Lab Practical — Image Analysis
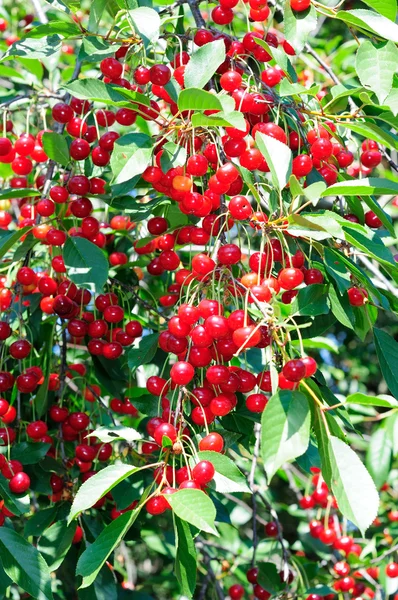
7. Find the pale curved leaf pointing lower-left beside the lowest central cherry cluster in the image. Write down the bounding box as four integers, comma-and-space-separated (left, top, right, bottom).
68, 463, 139, 523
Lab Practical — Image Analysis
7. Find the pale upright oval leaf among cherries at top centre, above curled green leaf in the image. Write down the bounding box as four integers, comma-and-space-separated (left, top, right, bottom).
184, 40, 225, 89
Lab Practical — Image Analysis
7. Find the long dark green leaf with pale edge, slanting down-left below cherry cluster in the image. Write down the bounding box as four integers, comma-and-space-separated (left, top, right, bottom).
76, 507, 140, 588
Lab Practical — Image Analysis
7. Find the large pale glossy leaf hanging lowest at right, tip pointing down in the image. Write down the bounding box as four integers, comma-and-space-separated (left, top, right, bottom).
329, 435, 379, 533
